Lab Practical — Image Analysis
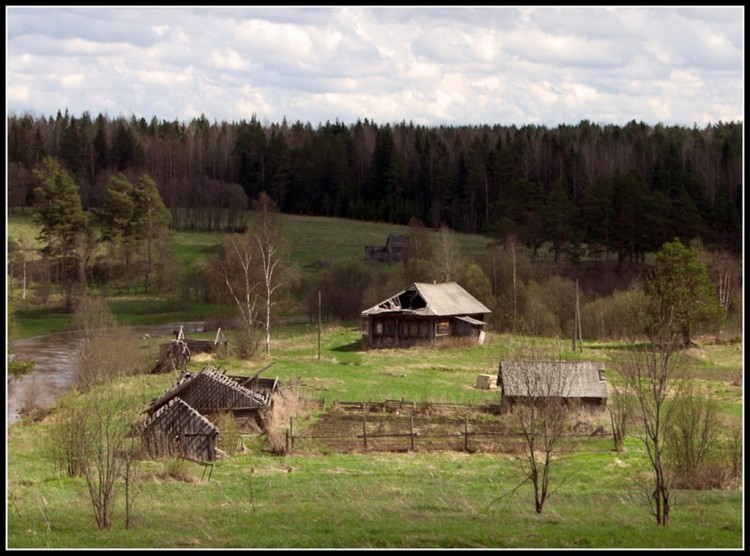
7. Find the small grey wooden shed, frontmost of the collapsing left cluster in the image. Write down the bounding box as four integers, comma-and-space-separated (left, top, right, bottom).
138, 398, 219, 461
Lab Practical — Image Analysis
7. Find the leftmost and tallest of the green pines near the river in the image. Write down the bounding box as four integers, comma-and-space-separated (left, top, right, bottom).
34, 157, 87, 308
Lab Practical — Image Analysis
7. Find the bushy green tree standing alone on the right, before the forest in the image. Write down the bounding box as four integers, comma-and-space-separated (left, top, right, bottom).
645, 239, 724, 347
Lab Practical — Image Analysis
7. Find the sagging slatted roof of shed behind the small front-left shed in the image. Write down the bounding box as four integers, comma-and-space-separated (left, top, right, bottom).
146, 366, 268, 413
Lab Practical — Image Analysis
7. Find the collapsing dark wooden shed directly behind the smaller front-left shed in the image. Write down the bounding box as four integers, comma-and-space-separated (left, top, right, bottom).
146, 366, 270, 426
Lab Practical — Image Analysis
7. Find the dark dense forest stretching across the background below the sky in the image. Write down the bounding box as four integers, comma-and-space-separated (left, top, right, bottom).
8, 110, 743, 261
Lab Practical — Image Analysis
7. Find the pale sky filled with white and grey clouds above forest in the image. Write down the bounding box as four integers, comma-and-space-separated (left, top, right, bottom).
6, 6, 744, 127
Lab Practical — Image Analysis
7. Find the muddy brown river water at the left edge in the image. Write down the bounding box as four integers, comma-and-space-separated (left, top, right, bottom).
6, 322, 205, 425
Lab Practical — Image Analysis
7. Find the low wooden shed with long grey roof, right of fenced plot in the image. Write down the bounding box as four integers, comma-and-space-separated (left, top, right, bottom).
497, 361, 609, 412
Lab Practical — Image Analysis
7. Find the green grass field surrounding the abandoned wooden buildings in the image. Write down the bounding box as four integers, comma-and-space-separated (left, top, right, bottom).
6, 212, 744, 549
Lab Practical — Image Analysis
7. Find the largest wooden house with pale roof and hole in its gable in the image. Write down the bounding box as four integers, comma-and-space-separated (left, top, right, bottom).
361, 282, 491, 347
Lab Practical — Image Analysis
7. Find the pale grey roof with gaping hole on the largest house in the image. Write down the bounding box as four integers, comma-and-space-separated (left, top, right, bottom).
362, 282, 492, 317
